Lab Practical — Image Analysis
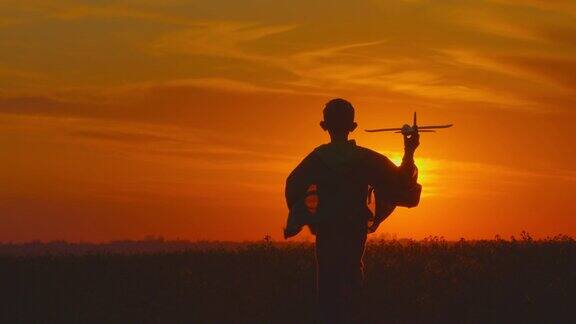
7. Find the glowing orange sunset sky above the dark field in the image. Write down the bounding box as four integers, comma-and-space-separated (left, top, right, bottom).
0, 0, 576, 241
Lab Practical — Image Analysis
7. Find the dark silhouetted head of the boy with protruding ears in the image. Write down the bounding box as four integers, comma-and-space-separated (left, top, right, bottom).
320, 98, 358, 136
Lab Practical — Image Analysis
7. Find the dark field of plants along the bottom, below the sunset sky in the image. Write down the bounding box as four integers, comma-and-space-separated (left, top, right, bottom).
0, 234, 576, 323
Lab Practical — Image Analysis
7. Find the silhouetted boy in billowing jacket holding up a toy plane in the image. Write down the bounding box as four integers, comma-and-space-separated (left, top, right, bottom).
284, 99, 421, 323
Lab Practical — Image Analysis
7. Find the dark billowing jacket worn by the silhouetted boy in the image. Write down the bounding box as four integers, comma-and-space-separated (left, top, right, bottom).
284, 140, 422, 238
